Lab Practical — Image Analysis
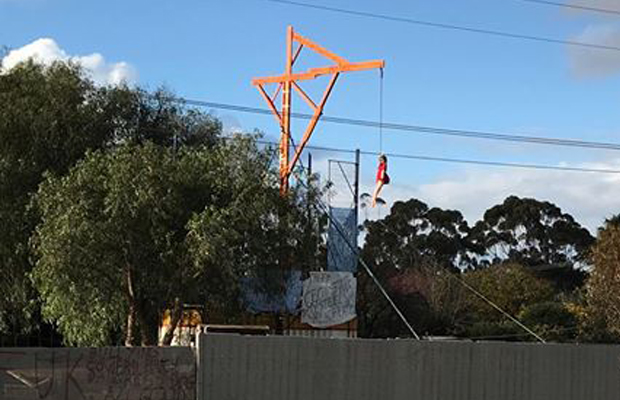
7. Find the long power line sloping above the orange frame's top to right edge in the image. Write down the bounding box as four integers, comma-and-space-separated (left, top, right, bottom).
266, 0, 620, 51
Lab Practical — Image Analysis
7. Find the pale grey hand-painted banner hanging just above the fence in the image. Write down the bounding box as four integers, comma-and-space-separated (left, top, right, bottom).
301, 272, 357, 328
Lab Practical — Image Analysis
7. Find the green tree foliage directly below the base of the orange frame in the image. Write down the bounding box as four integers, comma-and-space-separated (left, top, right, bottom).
188, 159, 326, 322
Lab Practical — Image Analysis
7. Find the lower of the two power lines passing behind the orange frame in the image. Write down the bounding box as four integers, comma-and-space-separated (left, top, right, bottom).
258, 140, 620, 174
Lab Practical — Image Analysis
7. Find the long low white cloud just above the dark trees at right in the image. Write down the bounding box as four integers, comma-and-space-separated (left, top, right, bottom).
376, 159, 620, 233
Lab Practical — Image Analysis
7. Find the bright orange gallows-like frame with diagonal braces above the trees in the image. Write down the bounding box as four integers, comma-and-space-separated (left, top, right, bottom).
252, 26, 385, 195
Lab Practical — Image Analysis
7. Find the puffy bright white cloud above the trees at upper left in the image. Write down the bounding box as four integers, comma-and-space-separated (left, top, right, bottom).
2, 38, 138, 85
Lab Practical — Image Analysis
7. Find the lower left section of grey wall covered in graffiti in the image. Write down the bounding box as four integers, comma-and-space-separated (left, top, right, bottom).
0, 347, 196, 400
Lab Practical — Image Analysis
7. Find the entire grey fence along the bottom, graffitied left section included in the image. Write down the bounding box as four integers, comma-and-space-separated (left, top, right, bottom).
0, 334, 620, 400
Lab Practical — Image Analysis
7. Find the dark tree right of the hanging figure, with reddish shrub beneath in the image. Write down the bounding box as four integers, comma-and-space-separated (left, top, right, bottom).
358, 199, 474, 337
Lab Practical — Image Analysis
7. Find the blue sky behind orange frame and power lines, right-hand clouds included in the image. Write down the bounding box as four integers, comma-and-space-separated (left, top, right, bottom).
0, 0, 620, 229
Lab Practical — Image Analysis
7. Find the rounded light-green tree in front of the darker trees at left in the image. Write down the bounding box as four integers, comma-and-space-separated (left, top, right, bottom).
33, 145, 195, 345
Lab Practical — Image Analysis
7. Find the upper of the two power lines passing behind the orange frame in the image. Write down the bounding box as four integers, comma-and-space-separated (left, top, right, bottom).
183, 98, 620, 151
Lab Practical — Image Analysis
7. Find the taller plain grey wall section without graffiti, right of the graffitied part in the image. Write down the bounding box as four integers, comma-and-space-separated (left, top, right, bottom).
198, 335, 620, 400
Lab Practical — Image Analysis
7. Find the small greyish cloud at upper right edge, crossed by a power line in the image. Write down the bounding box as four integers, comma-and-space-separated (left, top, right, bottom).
568, 24, 620, 77
